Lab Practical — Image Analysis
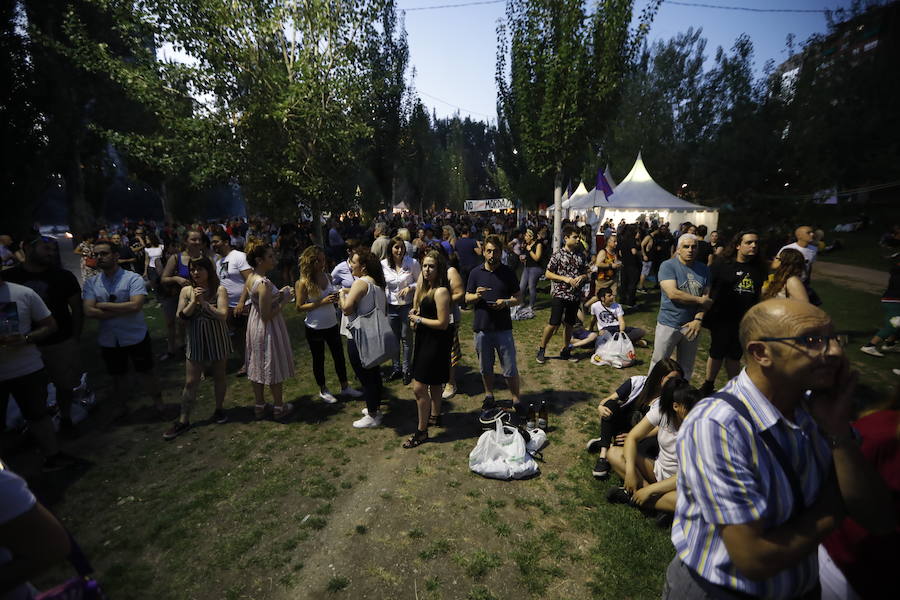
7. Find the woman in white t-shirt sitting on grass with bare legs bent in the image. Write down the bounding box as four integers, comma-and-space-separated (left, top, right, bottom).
606, 378, 701, 514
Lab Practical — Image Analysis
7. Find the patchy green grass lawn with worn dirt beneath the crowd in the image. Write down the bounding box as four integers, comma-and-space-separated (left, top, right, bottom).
12, 283, 900, 600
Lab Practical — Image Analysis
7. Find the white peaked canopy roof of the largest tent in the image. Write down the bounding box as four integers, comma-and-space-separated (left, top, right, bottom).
598, 152, 719, 231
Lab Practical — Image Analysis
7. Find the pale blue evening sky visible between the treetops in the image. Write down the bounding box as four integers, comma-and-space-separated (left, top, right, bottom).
397, 0, 850, 121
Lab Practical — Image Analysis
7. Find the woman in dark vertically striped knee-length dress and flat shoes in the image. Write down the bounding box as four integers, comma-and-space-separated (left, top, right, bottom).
163, 256, 231, 440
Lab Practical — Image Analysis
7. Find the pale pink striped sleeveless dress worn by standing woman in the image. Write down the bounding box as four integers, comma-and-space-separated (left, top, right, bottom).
246, 277, 294, 385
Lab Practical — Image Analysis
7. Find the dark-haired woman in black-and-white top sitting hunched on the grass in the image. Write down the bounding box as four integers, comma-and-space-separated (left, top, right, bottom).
587, 358, 684, 478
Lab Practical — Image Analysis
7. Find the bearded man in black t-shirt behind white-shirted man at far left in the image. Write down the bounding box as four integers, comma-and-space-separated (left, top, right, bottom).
3, 234, 84, 436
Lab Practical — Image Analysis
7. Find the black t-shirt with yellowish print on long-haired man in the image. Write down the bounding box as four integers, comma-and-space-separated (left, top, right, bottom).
703, 261, 766, 326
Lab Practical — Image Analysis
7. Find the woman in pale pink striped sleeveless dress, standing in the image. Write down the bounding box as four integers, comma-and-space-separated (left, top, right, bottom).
242, 244, 294, 419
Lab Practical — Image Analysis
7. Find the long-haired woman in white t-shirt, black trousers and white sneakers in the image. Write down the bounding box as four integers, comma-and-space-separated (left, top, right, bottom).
294, 246, 362, 404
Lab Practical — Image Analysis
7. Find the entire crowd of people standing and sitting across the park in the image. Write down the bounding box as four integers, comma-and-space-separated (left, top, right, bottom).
0, 211, 900, 598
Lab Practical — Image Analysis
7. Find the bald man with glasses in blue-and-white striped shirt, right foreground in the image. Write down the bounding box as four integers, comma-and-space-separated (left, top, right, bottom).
663, 299, 895, 599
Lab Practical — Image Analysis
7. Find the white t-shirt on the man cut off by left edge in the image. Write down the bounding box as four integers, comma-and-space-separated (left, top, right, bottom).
0, 282, 50, 381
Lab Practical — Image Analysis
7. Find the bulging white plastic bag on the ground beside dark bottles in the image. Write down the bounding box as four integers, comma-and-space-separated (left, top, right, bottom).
469, 419, 540, 479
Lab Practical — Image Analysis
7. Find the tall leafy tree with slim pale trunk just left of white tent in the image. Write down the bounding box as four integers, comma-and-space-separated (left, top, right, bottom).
496, 0, 659, 247
